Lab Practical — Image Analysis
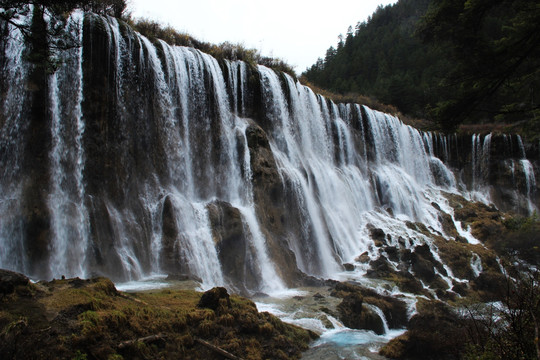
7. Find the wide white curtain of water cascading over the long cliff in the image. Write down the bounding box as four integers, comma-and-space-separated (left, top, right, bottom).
0, 10, 537, 292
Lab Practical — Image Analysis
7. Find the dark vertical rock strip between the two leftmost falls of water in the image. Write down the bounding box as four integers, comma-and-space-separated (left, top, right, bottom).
18, 7, 52, 276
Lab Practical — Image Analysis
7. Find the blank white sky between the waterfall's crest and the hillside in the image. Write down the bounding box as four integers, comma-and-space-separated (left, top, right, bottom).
128, 0, 396, 74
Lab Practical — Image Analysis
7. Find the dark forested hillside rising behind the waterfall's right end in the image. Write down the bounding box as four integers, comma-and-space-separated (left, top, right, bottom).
304, 0, 540, 137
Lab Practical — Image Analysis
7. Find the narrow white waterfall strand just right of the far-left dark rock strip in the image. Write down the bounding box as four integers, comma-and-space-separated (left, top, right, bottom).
48, 12, 89, 277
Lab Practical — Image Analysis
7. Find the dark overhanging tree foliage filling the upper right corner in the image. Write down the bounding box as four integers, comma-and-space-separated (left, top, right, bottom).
418, 0, 540, 130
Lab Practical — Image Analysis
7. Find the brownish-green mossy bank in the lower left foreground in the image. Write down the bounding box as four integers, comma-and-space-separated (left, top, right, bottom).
0, 278, 315, 360
